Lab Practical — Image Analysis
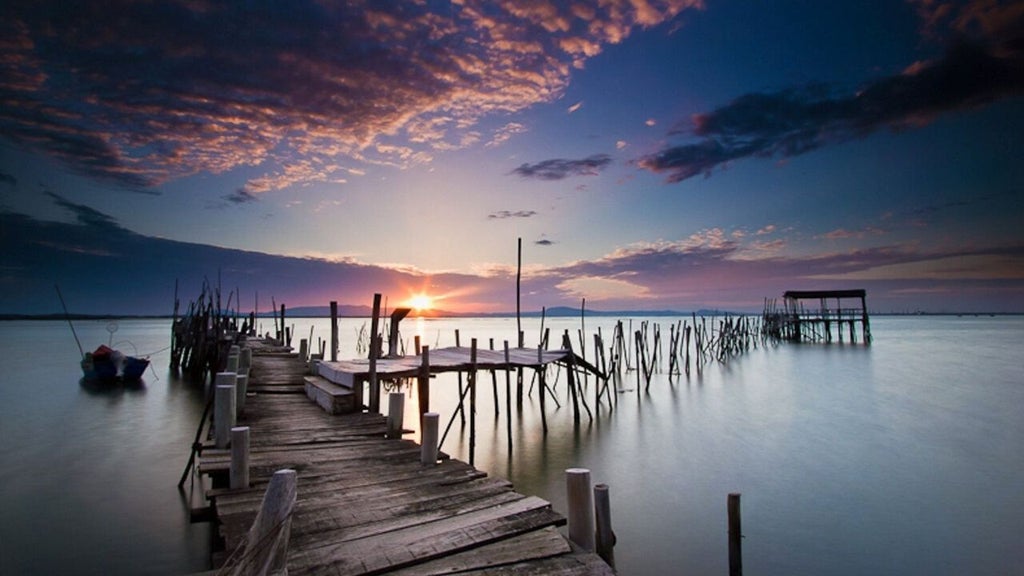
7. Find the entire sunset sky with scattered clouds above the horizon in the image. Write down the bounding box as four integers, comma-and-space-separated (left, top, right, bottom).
0, 0, 1024, 314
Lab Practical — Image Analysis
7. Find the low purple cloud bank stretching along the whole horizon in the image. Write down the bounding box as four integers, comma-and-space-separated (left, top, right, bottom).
0, 202, 1024, 314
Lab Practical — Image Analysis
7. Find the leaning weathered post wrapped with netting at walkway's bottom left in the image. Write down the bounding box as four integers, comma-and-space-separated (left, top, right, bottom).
230, 469, 298, 576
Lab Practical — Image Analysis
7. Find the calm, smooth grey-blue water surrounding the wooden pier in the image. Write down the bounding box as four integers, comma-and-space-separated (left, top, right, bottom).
0, 317, 1024, 575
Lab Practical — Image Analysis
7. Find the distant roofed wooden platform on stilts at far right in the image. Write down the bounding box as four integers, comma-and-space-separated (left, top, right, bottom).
763, 290, 871, 344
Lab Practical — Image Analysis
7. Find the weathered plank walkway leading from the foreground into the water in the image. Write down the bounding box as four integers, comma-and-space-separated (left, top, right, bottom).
199, 352, 613, 576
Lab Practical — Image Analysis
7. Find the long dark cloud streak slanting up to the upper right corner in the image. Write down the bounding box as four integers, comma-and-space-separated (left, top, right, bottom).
637, 3, 1024, 182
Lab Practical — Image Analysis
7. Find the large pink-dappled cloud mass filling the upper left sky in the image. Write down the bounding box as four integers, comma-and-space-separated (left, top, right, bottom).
0, 0, 701, 194
